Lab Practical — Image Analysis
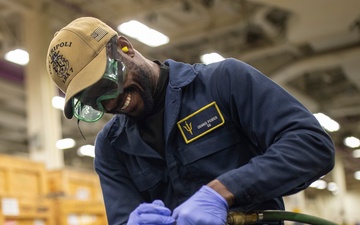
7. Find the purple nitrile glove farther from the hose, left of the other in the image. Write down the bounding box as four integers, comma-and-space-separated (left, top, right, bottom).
127, 200, 175, 225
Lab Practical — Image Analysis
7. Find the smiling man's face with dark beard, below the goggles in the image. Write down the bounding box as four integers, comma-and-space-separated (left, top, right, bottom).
102, 55, 156, 119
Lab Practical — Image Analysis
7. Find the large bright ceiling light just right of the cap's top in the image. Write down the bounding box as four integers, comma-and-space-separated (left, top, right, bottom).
117, 20, 169, 47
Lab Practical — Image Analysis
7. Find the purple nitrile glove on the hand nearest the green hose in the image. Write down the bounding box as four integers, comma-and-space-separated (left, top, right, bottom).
172, 186, 229, 225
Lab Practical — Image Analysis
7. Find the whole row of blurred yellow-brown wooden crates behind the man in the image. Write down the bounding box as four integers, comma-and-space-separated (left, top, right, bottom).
0, 154, 107, 225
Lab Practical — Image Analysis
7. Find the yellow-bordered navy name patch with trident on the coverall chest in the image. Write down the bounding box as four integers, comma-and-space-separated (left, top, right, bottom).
177, 102, 224, 144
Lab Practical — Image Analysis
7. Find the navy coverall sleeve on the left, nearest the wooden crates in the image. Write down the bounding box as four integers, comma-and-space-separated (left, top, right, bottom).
94, 127, 142, 225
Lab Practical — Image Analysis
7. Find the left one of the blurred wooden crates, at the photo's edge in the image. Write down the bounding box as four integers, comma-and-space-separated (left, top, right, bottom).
0, 155, 55, 225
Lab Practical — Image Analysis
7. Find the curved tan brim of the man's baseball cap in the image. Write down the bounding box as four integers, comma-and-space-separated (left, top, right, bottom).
64, 46, 107, 119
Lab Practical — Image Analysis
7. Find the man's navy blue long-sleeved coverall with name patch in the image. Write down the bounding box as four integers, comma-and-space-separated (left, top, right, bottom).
94, 59, 335, 225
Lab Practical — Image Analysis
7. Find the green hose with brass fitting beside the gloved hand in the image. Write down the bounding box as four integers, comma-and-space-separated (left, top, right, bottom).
227, 210, 338, 225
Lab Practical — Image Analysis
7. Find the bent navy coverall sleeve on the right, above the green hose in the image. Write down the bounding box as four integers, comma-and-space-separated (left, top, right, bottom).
211, 59, 335, 211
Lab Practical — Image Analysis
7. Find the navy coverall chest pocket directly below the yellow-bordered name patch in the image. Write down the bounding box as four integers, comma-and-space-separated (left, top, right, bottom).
179, 126, 242, 182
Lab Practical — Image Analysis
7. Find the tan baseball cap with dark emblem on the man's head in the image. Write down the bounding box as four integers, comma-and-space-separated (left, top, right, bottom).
46, 17, 117, 119
